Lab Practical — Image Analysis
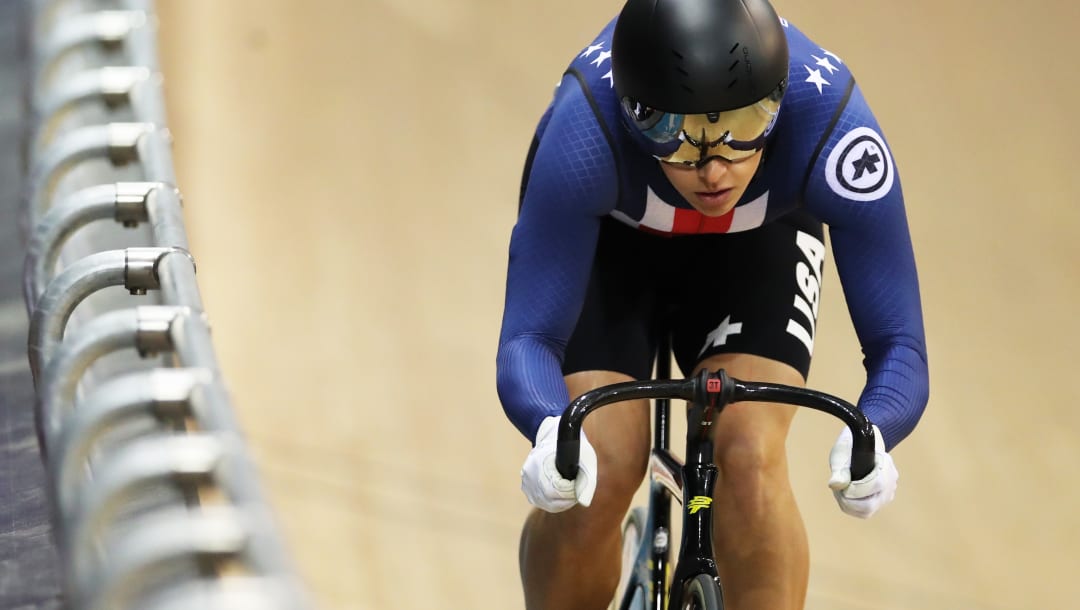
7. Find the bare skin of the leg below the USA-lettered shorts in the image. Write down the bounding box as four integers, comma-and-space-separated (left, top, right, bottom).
702, 354, 809, 610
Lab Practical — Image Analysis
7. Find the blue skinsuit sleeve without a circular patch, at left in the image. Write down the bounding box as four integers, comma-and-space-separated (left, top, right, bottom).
496, 74, 619, 440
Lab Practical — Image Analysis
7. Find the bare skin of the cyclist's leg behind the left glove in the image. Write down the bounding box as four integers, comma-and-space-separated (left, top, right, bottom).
518, 371, 650, 610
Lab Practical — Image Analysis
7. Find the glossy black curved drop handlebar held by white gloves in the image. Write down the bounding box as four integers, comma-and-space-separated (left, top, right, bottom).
555, 369, 875, 480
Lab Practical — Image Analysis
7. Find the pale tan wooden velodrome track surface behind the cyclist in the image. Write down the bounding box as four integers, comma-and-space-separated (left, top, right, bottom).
159, 0, 1080, 610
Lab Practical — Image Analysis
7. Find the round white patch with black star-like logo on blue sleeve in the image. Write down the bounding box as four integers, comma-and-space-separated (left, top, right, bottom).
825, 127, 895, 201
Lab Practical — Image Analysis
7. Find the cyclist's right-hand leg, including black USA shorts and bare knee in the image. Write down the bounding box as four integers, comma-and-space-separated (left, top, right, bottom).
672, 211, 825, 610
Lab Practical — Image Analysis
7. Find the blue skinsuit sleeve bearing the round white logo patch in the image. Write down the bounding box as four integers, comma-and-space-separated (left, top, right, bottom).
805, 81, 930, 449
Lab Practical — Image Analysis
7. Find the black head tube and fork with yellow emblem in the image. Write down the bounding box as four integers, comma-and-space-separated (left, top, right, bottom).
667, 443, 718, 610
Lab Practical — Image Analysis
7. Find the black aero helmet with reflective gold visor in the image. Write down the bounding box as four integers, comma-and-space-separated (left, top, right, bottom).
611, 0, 788, 164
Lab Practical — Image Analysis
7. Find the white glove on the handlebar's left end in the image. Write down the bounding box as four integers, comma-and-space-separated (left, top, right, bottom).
522, 417, 596, 513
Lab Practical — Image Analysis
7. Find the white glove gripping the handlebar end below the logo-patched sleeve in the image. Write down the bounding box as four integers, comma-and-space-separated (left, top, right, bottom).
828, 425, 900, 519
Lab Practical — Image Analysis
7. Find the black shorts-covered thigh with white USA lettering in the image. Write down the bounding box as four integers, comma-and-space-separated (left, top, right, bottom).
671, 213, 825, 380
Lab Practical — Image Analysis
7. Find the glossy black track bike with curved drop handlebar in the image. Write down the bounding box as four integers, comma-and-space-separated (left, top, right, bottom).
555, 343, 875, 610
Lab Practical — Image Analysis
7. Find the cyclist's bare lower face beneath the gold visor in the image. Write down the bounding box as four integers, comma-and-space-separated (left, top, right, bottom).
660, 150, 761, 216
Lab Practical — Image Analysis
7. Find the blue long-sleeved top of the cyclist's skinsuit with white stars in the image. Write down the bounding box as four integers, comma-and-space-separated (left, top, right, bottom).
497, 21, 929, 448
